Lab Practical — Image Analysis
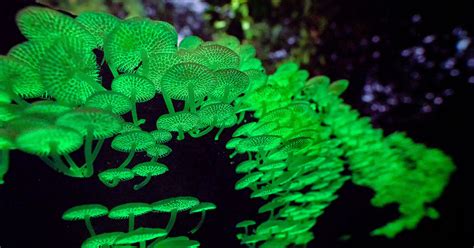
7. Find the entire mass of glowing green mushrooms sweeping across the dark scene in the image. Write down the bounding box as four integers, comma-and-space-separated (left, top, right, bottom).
0, 4, 454, 248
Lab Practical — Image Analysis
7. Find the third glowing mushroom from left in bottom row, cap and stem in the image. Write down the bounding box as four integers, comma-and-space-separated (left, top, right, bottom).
152, 196, 199, 233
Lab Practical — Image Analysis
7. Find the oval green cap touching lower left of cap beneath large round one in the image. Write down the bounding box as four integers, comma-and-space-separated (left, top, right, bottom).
85, 91, 132, 115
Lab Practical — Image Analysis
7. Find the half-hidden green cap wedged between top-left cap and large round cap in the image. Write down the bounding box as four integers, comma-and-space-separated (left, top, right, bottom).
75, 11, 120, 48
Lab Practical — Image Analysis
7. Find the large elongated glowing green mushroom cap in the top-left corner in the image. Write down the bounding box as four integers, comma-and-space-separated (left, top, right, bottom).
16, 6, 95, 48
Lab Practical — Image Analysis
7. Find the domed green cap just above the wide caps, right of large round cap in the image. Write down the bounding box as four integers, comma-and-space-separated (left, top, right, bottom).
194, 44, 240, 71
